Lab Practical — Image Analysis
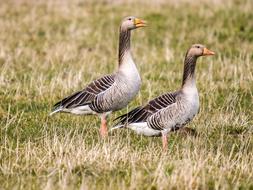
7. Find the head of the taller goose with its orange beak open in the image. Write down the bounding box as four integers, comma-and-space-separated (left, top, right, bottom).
120, 16, 147, 30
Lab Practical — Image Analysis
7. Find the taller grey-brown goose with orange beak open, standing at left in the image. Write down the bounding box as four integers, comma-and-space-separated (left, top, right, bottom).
49, 16, 146, 137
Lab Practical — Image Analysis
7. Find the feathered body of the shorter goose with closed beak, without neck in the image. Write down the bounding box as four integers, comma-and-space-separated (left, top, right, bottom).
113, 89, 199, 136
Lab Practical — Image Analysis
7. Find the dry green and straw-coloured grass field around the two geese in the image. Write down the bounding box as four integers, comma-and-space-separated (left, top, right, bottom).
0, 0, 253, 190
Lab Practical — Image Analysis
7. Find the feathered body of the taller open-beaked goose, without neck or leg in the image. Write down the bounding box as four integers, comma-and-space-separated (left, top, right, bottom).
51, 55, 141, 115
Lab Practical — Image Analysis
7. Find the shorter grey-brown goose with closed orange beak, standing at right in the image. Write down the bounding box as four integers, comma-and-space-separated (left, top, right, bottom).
111, 44, 215, 150
